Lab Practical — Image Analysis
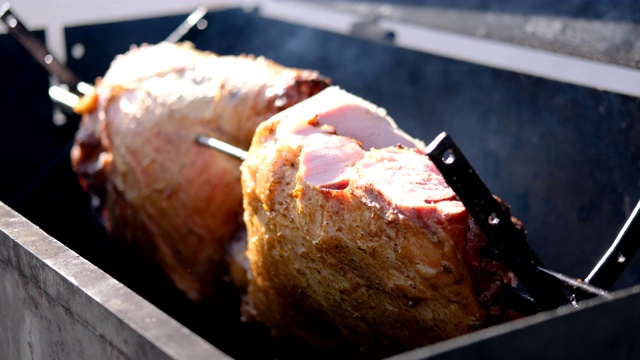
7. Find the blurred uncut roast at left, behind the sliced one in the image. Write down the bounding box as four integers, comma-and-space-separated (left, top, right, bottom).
71, 43, 328, 301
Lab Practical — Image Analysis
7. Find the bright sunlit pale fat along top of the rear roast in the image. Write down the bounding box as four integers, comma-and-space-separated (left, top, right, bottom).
99, 42, 284, 119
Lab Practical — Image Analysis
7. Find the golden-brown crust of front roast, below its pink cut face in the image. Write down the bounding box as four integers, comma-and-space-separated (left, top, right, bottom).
242, 121, 504, 356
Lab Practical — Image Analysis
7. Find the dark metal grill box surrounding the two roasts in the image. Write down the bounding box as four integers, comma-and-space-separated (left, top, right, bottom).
0, 3, 640, 359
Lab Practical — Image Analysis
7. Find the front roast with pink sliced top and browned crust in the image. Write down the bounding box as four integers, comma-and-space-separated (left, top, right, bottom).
241, 87, 515, 357
